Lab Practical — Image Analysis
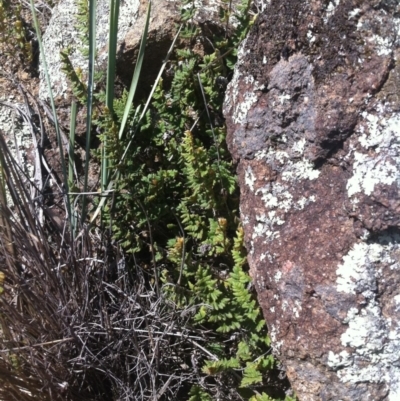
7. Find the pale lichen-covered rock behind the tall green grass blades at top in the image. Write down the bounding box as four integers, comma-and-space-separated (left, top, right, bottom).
40, 0, 239, 101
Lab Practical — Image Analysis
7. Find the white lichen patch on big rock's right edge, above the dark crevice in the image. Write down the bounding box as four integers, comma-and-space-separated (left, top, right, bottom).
347, 105, 400, 197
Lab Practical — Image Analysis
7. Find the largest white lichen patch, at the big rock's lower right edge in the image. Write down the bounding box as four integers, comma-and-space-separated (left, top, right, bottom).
328, 235, 400, 401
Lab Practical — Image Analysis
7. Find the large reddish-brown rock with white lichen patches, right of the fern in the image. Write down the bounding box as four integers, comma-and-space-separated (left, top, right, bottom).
225, 0, 400, 401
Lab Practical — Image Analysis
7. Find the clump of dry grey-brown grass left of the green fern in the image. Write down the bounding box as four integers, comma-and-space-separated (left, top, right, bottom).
0, 131, 209, 400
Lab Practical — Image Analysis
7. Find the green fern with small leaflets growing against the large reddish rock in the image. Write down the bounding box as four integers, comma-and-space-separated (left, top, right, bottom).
66, 1, 294, 401
